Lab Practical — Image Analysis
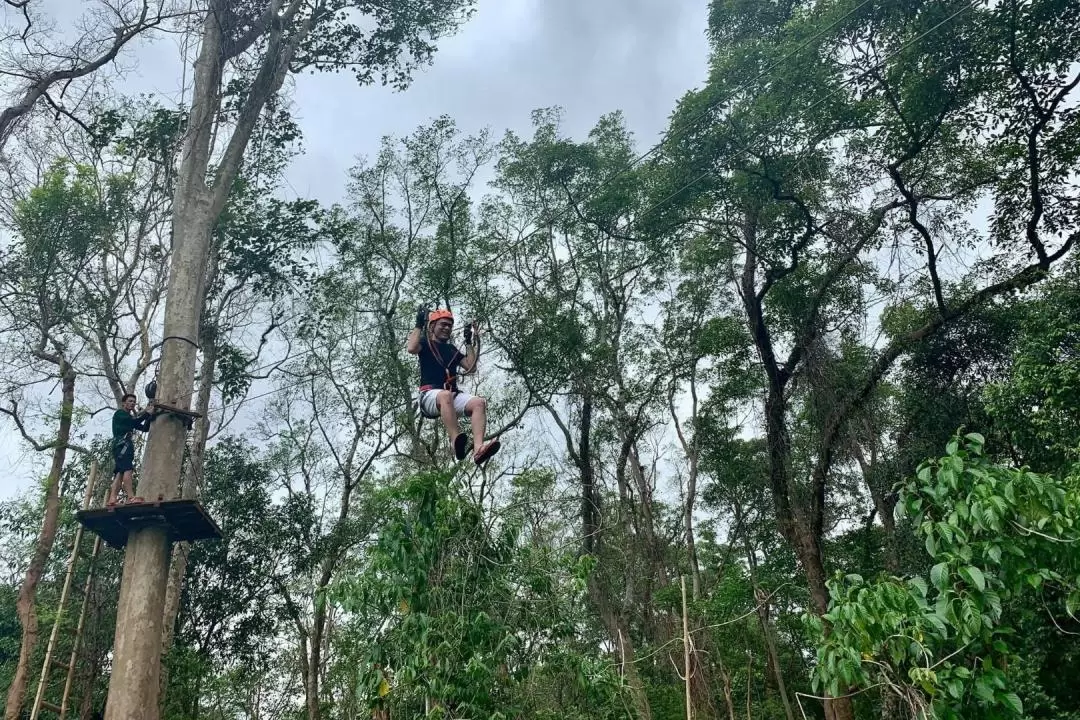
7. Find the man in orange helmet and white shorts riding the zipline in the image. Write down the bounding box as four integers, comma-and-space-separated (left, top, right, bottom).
405, 308, 500, 465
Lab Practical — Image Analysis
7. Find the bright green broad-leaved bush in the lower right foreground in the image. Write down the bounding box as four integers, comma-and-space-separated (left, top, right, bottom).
813, 433, 1080, 718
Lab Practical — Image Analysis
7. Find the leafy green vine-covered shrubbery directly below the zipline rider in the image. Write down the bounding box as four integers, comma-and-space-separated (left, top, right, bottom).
332, 473, 618, 720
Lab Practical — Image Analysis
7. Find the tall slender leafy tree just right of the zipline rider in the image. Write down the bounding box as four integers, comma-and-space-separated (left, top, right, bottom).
472, 109, 674, 718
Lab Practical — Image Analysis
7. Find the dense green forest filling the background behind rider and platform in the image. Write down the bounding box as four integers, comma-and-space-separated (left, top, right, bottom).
0, 0, 1080, 720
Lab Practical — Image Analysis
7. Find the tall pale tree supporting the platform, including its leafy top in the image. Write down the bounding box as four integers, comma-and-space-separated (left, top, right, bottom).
106, 0, 471, 720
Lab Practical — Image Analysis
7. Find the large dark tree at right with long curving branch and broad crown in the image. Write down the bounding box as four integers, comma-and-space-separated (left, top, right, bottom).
669, 2, 1080, 720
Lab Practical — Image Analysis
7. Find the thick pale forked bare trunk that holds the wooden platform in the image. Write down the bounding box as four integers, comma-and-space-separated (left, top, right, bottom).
106, 0, 310, 720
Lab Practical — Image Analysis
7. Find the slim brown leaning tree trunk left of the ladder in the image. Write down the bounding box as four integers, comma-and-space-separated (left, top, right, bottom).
4, 367, 75, 720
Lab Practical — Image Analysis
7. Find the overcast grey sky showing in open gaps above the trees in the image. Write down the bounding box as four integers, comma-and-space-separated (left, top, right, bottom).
0, 0, 707, 498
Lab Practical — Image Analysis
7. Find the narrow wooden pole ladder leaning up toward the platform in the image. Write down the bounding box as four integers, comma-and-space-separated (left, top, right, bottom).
30, 460, 102, 720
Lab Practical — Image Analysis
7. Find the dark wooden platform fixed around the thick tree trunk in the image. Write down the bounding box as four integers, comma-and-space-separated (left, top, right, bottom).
76, 500, 221, 547
